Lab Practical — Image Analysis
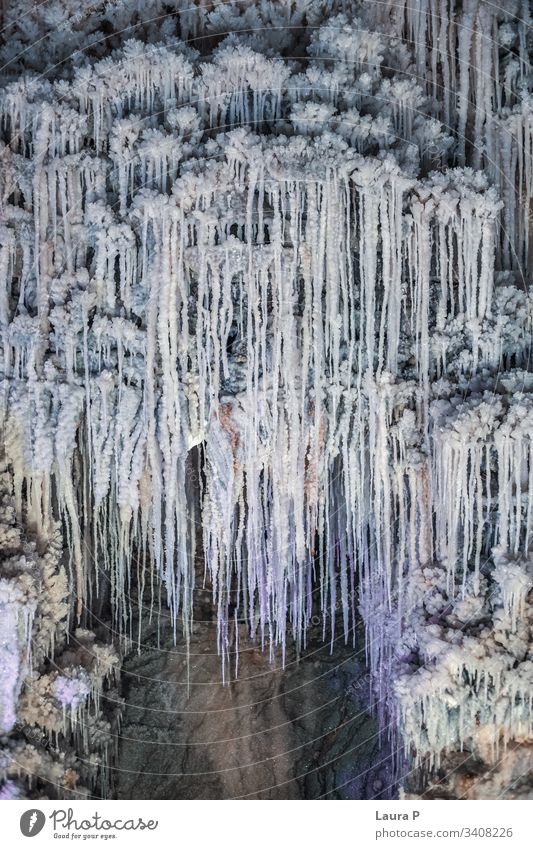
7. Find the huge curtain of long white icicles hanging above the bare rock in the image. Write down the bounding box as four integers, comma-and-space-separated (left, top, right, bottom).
0, 0, 533, 796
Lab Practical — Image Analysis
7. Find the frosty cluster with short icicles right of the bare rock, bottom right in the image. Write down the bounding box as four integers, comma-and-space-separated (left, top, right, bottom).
393, 549, 533, 798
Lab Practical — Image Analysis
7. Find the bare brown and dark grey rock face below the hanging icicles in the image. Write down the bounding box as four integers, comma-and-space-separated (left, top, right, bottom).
115, 607, 395, 799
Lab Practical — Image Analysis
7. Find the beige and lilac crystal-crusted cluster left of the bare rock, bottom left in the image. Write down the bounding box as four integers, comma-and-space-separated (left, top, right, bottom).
0, 469, 120, 798
